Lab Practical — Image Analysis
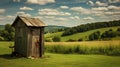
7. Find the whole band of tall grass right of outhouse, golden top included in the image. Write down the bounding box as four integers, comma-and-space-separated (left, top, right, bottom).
45, 41, 120, 56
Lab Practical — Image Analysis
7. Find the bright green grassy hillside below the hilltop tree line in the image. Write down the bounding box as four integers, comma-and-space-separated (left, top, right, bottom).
45, 26, 120, 41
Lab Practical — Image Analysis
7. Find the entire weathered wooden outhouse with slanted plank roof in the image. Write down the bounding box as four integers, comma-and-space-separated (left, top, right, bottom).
12, 16, 45, 58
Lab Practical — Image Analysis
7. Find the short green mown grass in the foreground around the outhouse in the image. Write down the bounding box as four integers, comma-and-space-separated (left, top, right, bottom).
0, 42, 120, 67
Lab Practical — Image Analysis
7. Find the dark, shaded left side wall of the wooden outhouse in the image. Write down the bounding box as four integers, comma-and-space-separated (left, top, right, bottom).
15, 20, 28, 56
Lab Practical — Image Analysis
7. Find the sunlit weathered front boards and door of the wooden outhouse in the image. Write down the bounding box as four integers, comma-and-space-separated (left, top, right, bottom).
28, 27, 40, 57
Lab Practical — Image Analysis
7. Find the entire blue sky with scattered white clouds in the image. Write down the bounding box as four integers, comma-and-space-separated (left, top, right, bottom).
0, 0, 120, 27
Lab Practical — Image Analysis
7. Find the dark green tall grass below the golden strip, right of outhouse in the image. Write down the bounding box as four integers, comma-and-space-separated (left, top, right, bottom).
45, 45, 120, 56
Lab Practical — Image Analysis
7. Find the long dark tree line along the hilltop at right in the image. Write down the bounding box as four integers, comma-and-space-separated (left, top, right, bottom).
62, 20, 120, 36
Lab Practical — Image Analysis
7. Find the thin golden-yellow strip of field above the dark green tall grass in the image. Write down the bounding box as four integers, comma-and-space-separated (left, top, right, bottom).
45, 40, 120, 47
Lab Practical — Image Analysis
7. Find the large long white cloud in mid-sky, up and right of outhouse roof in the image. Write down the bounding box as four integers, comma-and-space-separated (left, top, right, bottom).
38, 8, 71, 16
